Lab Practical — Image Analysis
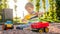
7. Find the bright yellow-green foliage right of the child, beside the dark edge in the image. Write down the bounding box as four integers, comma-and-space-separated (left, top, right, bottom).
40, 0, 60, 22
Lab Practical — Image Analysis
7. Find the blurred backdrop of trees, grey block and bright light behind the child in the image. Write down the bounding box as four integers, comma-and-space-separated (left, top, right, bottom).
0, 0, 60, 23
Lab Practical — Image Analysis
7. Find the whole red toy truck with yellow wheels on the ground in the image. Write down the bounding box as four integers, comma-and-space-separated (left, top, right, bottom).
31, 22, 49, 33
